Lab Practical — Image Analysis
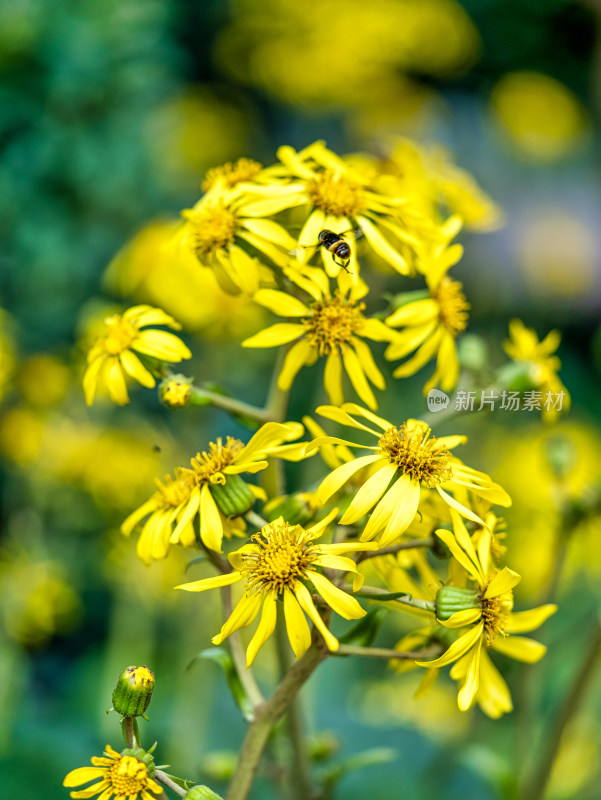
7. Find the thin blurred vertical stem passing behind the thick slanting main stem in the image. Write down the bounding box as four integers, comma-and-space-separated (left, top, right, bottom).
275, 617, 312, 800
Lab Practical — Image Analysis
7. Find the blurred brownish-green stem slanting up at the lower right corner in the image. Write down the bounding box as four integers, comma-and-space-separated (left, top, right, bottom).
523, 622, 601, 800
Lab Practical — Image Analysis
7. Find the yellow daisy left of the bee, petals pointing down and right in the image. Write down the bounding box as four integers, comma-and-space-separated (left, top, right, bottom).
176, 181, 295, 294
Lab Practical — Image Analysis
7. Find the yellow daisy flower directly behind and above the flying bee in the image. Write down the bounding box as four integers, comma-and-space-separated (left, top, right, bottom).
238, 141, 439, 277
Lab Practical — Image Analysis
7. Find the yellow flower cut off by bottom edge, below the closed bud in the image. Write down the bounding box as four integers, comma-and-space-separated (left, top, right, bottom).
63, 744, 163, 800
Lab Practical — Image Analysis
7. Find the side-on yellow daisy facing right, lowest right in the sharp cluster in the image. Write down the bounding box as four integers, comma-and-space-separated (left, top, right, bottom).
417, 517, 557, 717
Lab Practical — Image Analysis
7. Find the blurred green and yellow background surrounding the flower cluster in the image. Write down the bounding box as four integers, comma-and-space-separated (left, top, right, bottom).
0, 0, 601, 800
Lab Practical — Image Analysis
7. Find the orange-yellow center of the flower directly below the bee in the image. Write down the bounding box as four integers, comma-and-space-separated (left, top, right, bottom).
302, 292, 365, 356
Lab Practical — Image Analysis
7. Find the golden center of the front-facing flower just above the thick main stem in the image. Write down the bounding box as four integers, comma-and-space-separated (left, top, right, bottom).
241, 521, 311, 594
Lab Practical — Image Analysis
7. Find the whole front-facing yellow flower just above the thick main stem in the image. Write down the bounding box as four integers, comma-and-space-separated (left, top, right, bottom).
176, 508, 374, 666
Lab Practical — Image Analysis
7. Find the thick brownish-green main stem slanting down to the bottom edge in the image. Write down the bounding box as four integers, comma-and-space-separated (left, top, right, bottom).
226, 634, 328, 800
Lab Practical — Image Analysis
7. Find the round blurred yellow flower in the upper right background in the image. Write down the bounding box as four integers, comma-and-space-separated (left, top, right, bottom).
491, 72, 588, 161
